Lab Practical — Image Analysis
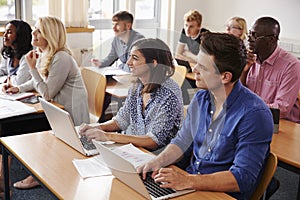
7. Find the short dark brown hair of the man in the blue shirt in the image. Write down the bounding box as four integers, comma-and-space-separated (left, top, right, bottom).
200, 32, 247, 82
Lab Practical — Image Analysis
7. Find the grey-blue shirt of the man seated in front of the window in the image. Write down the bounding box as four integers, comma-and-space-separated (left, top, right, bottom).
101, 30, 144, 72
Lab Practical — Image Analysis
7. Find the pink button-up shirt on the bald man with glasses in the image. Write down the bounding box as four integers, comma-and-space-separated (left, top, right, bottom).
246, 47, 300, 123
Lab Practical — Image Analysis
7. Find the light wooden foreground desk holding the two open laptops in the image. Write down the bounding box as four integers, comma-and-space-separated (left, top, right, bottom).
0, 131, 233, 200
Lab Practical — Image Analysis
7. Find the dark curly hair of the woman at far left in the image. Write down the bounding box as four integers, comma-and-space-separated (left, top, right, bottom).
1, 20, 33, 60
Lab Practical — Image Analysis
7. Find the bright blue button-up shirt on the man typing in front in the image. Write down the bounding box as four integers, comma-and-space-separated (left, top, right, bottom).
171, 81, 273, 199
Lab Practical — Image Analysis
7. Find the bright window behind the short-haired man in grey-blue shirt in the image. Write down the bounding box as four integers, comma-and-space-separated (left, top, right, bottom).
88, 0, 161, 61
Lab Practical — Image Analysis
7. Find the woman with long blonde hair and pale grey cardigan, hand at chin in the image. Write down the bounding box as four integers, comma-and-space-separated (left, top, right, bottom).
2, 17, 89, 189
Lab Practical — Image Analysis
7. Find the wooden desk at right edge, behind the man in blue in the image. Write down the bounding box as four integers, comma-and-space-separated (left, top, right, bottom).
271, 120, 300, 200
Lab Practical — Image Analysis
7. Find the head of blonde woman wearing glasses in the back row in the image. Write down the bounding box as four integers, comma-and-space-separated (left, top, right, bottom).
226, 17, 248, 41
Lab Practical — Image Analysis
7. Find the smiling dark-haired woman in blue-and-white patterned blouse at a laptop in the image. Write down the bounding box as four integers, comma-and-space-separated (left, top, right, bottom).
80, 39, 183, 150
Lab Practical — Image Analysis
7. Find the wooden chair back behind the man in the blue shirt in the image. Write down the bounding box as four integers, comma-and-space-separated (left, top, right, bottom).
251, 152, 277, 200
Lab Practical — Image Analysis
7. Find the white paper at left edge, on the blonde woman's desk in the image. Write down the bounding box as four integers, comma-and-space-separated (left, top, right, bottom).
0, 99, 36, 119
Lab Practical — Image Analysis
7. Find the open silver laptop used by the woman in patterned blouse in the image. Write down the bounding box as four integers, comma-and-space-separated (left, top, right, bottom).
39, 98, 98, 156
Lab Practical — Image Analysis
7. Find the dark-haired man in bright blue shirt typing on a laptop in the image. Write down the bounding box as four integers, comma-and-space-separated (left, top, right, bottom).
138, 33, 273, 199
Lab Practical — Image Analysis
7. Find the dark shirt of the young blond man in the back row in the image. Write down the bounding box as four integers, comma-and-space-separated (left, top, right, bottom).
179, 28, 208, 55
